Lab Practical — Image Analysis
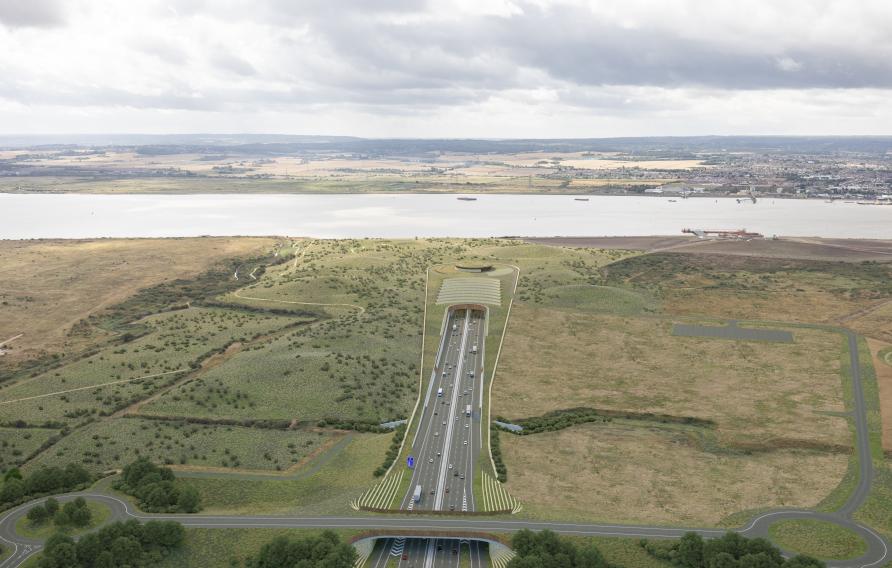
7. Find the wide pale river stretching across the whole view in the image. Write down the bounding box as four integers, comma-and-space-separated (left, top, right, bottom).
0, 194, 892, 239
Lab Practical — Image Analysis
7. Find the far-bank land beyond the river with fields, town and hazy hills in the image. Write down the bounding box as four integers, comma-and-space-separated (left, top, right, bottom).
0, 135, 892, 204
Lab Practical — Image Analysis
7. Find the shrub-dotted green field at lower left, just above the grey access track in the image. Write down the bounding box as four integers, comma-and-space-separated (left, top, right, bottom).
26, 417, 333, 473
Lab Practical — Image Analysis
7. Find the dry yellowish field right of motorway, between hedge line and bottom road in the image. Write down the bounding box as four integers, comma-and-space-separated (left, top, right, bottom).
500, 424, 847, 526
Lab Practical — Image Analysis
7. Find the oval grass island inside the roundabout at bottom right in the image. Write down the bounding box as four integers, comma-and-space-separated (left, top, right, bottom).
768, 519, 867, 560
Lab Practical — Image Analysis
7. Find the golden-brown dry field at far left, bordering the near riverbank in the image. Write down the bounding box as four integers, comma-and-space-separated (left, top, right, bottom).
0, 237, 277, 366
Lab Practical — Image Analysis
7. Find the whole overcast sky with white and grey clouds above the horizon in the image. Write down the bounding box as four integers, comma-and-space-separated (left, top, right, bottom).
0, 0, 892, 138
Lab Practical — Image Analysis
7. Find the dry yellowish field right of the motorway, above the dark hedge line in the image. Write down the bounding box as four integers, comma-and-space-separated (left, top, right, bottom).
493, 304, 851, 448
